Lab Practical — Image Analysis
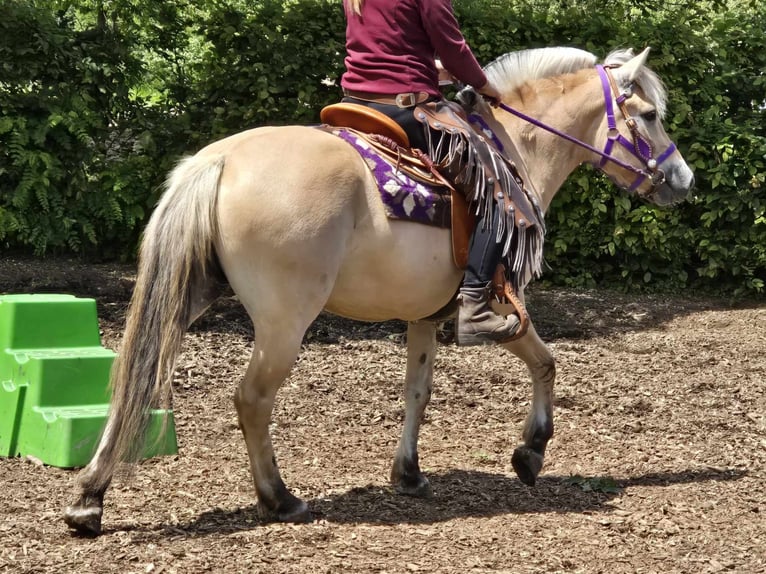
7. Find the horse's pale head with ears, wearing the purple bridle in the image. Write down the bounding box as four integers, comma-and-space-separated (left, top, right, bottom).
595, 48, 694, 205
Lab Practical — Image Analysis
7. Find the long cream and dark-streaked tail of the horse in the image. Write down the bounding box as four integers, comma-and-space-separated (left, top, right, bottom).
80, 155, 224, 492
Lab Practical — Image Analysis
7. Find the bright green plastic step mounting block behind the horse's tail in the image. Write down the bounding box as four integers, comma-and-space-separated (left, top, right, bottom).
0, 295, 177, 468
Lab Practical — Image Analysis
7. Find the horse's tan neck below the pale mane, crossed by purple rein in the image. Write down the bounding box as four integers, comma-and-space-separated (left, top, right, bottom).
491, 74, 602, 212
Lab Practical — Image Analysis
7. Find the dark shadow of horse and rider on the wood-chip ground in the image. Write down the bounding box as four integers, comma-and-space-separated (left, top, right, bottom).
122, 468, 747, 537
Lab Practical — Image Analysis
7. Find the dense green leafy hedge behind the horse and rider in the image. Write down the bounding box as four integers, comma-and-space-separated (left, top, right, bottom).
0, 0, 766, 295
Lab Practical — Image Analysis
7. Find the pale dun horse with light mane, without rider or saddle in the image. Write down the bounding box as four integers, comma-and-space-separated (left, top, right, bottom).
64, 47, 694, 535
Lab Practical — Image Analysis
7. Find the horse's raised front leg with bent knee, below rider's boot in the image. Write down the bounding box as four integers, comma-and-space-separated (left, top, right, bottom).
505, 325, 556, 486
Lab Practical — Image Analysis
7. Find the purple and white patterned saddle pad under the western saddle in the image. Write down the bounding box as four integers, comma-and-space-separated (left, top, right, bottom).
332, 129, 452, 229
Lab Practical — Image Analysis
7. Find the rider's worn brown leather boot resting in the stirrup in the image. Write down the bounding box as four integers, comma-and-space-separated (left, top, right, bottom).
455, 283, 519, 346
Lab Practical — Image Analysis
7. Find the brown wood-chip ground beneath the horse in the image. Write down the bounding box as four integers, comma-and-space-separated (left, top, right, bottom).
0, 259, 766, 574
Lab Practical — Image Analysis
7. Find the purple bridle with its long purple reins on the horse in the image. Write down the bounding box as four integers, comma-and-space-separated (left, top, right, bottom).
470, 65, 676, 198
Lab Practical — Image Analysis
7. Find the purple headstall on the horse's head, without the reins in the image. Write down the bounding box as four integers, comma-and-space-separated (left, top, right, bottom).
596, 65, 676, 197
